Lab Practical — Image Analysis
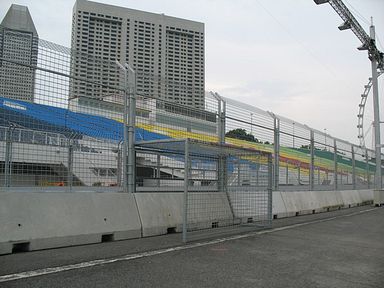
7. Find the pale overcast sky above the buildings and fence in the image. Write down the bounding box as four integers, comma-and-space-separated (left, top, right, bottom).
0, 0, 384, 146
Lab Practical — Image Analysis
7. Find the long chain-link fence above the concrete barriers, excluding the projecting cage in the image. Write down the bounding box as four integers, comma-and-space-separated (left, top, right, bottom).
0, 29, 376, 192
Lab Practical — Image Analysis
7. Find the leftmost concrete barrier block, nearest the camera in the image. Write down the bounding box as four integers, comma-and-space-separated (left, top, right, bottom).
0, 192, 141, 254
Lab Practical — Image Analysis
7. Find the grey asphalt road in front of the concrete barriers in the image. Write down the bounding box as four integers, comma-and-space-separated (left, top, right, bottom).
0, 206, 384, 288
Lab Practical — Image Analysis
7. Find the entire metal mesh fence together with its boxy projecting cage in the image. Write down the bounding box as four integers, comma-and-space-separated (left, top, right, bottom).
0, 29, 375, 241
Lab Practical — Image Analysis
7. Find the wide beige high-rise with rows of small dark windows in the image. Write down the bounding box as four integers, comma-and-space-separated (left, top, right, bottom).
70, 0, 204, 108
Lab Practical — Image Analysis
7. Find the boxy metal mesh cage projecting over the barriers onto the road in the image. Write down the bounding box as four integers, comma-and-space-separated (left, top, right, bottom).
137, 138, 272, 242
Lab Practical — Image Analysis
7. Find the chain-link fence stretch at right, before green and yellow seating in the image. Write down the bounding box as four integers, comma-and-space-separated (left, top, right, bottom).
222, 97, 376, 191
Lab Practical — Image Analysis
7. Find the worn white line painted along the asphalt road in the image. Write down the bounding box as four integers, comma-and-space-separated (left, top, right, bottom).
0, 208, 378, 283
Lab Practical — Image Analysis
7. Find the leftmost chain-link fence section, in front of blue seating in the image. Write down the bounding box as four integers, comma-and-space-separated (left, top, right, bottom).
0, 31, 123, 191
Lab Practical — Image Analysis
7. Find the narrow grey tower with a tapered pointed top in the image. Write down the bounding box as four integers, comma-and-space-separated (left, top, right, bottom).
0, 4, 38, 102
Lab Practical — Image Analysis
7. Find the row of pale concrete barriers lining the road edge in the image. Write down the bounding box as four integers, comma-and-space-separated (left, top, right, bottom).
0, 190, 373, 254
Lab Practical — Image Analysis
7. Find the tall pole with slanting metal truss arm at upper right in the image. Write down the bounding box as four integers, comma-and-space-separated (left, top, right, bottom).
314, 0, 384, 190
